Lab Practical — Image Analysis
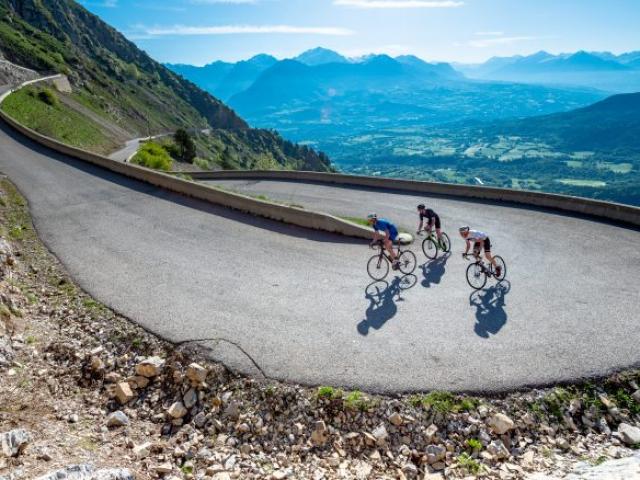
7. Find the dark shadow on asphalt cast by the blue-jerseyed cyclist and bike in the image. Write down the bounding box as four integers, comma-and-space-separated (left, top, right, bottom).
357, 274, 418, 336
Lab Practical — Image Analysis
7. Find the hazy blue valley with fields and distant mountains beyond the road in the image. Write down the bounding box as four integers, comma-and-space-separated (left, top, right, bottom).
169, 48, 640, 204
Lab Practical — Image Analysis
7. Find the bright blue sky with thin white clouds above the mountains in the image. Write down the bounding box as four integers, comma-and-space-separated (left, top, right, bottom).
80, 0, 640, 65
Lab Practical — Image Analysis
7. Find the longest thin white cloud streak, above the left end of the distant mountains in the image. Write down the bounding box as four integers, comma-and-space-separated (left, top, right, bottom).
138, 25, 354, 38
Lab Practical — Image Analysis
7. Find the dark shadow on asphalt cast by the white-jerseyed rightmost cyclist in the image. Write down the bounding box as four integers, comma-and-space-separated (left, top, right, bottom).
469, 280, 511, 338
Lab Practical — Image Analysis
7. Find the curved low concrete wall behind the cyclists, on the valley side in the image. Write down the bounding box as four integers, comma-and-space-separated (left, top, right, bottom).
184, 170, 640, 227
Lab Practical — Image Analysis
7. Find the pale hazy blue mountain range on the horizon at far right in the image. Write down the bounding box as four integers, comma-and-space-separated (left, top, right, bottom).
456, 51, 640, 93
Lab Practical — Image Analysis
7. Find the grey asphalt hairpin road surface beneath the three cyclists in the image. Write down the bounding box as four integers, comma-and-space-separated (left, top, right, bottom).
0, 95, 640, 392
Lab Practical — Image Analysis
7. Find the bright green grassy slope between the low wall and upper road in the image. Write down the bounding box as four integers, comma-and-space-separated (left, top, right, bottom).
2, 87, 118, 153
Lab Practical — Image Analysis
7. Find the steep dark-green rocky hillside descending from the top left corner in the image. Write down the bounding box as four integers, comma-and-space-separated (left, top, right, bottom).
0, 0, 328, 170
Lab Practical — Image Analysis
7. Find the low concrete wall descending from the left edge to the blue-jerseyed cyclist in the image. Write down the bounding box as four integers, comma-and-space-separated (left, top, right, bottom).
0, 80, 372, 239
